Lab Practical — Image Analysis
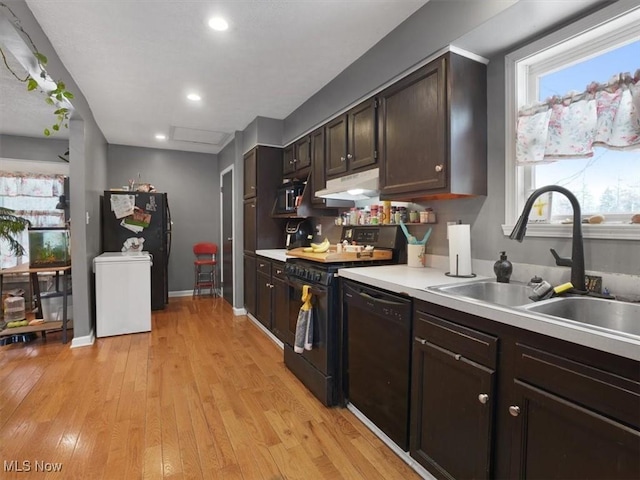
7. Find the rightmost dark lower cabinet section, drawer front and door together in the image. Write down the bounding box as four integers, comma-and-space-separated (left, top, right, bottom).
508, 343, 640, 480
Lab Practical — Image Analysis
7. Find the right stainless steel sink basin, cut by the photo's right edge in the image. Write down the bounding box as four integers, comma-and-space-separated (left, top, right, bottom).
522, 297, 640, 336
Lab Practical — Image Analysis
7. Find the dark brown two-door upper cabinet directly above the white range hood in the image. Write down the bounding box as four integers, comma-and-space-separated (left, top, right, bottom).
325, 98, 377, 178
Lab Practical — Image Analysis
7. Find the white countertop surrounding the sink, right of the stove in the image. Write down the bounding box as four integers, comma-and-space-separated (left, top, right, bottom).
338, 265, 640, 361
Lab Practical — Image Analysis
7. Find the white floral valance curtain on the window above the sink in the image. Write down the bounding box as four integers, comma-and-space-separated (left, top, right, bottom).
516, 70, 640, 165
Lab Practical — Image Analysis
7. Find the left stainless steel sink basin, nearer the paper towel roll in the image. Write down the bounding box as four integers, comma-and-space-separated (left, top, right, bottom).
429, 280, 533, 307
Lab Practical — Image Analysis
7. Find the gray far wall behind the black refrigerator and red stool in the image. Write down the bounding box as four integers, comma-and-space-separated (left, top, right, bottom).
107, 145, 220, 292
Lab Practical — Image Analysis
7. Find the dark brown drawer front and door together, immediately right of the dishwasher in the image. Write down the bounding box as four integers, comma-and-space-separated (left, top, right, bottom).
411, 311, 497, 479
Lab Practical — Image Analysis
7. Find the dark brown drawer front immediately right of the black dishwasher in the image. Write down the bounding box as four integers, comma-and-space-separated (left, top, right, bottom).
414, 312, 498, 369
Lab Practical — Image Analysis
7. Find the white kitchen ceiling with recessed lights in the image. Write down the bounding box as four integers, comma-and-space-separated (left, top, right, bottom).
16, 0, 426, 153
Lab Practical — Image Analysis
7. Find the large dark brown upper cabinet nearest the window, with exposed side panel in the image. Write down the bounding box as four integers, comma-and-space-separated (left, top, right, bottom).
378, 52, 487, 200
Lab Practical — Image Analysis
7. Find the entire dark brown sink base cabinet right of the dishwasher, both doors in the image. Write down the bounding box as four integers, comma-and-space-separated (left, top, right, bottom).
410, 300, 640, 480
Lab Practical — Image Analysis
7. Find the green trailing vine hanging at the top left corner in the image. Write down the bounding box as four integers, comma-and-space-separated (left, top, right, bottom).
0, 2, 73, 137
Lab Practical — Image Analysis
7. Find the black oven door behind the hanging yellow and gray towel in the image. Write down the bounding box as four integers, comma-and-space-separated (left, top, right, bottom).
286, 278, 332, 375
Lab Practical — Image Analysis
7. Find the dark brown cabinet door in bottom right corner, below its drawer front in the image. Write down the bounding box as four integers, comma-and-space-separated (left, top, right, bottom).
509, 380, 640, 480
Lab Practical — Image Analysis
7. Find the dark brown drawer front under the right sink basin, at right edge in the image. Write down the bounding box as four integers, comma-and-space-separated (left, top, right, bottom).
516, 343, 640, 428
